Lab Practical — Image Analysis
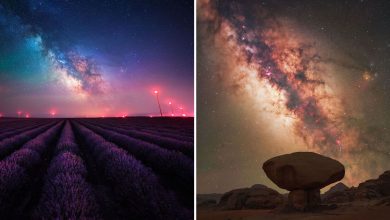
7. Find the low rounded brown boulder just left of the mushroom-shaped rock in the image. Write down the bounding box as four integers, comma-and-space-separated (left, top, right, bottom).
218, 184, 283, 210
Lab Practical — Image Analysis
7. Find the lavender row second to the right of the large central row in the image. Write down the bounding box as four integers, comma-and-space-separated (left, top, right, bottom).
78, 124, 194, 197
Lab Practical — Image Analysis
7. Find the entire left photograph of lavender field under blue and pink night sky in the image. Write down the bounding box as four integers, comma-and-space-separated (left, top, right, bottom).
0, 0, 194, 220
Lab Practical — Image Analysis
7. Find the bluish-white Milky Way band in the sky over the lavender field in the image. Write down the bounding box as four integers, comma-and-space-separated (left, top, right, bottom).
0, 1, 104, 95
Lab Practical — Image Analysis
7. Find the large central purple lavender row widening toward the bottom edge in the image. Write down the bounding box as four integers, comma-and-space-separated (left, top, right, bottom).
34, 122, 100, 219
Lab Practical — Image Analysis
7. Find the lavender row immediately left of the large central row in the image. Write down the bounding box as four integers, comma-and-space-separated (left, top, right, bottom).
0, 123, 62, 217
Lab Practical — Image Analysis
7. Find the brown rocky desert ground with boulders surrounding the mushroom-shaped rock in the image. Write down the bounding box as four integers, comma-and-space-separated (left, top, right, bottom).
197, 171, 390, 220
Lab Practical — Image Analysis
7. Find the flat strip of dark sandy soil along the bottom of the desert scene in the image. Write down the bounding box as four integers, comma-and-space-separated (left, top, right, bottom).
197, 204, 390, 220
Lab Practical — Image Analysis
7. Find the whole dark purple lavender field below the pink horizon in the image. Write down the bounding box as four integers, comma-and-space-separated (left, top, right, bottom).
0, 117, 194, 219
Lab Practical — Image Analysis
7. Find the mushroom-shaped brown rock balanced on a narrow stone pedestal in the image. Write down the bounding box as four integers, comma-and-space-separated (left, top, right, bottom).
263, 152, 345, 210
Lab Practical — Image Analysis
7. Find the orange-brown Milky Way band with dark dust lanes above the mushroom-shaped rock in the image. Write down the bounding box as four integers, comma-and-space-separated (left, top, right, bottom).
199, 1, 389, 192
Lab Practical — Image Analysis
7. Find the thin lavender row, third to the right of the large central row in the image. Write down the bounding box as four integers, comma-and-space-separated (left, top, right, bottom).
84, 122, 194, 158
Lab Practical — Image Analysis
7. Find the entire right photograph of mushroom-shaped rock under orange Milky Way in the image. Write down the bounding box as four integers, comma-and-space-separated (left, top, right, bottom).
196, 0, 390, 220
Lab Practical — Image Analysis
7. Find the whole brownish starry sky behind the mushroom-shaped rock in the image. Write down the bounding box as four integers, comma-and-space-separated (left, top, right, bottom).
197, 0, 390, 193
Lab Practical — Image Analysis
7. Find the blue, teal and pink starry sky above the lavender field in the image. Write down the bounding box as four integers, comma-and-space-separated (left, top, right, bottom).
0, 0, 194, 117
